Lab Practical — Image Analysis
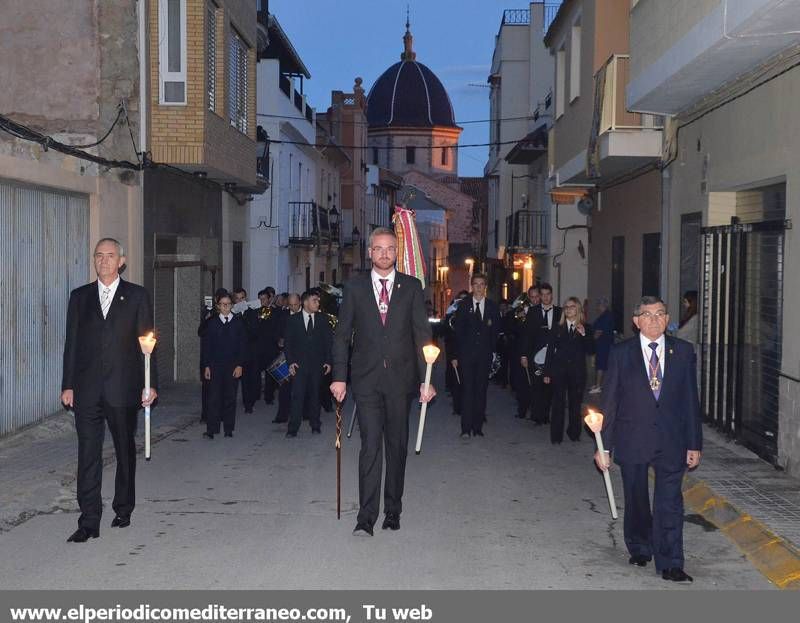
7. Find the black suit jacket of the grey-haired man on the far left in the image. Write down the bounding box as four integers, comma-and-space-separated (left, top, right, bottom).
61, 279, 158, 408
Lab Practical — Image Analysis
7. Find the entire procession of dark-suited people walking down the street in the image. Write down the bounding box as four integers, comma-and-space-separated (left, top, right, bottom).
61, 233, 702, 582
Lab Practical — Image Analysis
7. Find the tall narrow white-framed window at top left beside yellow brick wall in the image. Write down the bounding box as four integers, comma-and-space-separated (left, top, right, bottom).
158, 0, 186, 105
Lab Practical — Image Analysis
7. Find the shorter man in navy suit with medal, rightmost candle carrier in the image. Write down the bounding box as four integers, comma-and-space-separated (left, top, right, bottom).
595, 296, 703, 582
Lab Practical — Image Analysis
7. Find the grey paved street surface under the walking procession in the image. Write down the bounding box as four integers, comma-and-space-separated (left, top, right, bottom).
0, 372, 771, 590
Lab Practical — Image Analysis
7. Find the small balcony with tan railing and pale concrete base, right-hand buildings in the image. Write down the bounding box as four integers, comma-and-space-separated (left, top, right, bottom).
587, 54, 663, 181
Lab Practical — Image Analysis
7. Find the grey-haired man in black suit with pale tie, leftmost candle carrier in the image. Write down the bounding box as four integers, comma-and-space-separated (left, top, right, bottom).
61, 238, 158, 543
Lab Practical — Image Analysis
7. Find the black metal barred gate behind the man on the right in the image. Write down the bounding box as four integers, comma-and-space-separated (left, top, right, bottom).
701, 214, 785, 462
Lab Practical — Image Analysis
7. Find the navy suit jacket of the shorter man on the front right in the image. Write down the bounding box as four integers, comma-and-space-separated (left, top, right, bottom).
602, 335, 703, 467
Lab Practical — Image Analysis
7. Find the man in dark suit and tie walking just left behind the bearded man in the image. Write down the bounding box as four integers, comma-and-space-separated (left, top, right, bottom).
284, 289, 333, 437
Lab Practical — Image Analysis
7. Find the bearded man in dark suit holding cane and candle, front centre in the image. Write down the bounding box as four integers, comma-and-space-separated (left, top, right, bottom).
331, 227, 436, 536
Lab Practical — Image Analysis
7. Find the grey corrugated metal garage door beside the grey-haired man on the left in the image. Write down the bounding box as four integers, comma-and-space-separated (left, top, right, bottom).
0, 180, 89, 435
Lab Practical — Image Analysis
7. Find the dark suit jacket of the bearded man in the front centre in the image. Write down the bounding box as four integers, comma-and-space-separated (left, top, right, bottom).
333, 272, 432, 393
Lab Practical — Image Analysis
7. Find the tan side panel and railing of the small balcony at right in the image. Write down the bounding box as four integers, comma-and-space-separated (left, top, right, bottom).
595, 54, 664, 134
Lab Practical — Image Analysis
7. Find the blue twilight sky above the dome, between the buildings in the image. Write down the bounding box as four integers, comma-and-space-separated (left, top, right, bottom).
269, 0, 528, 176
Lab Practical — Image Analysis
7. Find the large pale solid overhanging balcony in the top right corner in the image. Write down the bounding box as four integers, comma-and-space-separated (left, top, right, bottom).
627, 0, 800, 115
